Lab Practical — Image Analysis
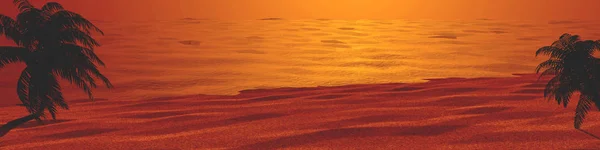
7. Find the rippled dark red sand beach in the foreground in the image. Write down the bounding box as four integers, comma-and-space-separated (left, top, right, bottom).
0, 75, 600, 149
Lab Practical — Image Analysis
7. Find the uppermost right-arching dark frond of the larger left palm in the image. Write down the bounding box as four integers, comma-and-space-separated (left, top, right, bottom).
50, 10, 104, 35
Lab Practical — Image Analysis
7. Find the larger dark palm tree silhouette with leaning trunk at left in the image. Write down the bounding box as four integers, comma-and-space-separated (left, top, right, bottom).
0, 0, 112, 136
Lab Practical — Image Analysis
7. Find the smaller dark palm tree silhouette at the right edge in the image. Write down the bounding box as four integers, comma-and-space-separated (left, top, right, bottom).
536, 34, 600, 129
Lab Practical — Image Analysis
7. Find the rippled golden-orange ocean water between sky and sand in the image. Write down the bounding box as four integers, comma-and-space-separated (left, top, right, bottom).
0, 18, 600, 104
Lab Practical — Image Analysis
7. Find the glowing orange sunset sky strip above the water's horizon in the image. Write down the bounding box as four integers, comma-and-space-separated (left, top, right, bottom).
0, 0, 600, 20
